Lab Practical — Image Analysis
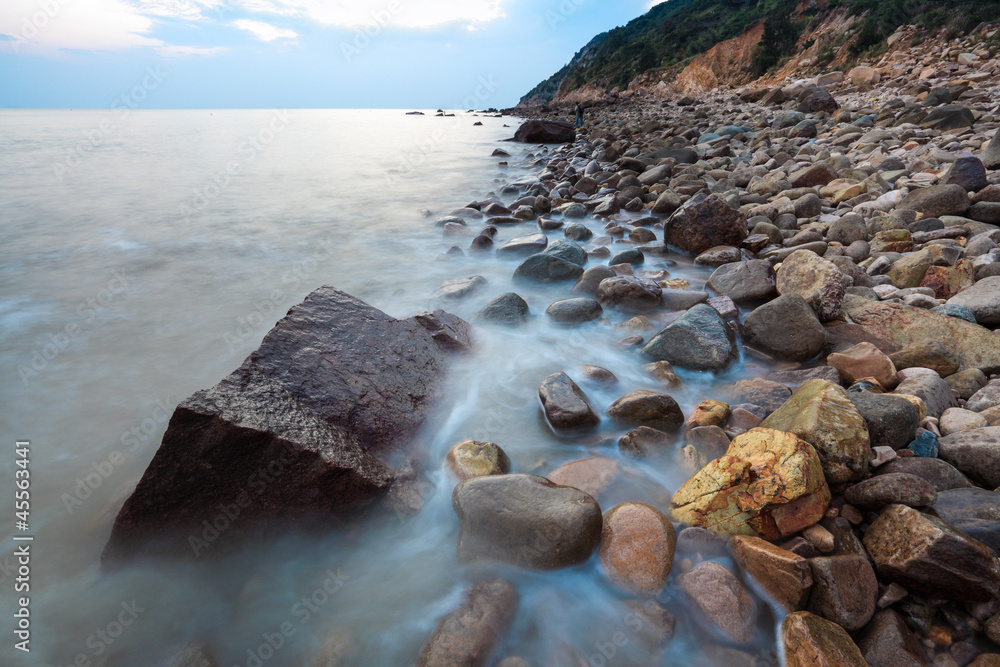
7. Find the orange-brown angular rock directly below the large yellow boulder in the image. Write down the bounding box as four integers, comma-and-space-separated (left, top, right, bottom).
729, 535, 813, 612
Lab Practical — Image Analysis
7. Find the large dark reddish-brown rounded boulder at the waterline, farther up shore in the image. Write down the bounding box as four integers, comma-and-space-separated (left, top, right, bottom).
663, 192, 747, 255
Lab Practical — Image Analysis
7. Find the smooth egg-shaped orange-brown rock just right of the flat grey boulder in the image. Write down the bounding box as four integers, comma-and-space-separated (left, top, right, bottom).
597, 503, 676, 596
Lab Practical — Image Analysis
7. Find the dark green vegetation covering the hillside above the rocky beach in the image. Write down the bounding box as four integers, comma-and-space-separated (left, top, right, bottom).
521, 0, 1000, 104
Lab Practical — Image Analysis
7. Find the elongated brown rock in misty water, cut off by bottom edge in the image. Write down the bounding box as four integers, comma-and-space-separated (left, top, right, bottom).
417, 579, 517, 667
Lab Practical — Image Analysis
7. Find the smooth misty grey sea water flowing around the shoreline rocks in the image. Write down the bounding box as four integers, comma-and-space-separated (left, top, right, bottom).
0, 110, 773, 666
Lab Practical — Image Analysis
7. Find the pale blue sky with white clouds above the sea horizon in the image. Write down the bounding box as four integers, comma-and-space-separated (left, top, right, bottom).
0, 0, 664, 109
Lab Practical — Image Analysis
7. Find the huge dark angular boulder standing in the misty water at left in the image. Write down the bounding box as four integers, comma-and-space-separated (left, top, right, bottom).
102, 287, 470, 562
